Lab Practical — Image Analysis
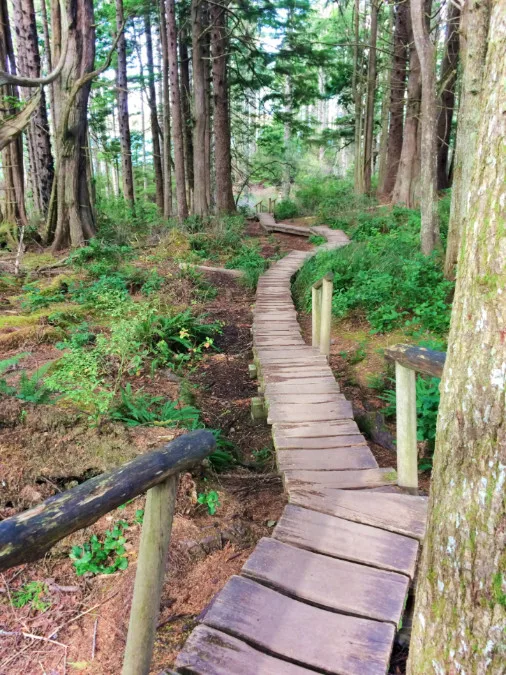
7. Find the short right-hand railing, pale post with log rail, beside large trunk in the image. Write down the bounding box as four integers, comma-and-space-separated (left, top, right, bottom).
385, 345, 446, 493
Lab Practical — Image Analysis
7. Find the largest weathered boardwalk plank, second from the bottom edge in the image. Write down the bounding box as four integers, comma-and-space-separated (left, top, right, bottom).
204, 577, 394, 675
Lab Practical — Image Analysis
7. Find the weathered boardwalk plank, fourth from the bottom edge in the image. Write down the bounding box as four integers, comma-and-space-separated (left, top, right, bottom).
272, 504, 419, 578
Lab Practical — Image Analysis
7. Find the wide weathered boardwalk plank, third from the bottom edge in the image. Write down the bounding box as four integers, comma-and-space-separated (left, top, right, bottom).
241, 539, 409, 625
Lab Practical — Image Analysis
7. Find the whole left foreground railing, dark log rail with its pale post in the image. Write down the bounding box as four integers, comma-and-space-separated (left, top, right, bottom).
0, 431, 216, 675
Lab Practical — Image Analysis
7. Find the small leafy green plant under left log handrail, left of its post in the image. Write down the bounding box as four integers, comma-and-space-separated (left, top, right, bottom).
70, 520, 128, 576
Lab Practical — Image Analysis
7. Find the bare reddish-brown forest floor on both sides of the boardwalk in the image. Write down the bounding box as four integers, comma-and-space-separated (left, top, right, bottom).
0, 221, 422, 675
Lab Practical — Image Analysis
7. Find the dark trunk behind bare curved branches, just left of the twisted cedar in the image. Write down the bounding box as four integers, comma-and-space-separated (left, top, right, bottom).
13, 0, 54, 218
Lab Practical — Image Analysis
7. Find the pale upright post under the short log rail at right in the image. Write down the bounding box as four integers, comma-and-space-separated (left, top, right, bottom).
395, 361, 418, 494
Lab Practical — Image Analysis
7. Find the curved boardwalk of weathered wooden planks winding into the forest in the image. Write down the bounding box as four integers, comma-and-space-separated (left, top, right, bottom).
176, 214, 426, 675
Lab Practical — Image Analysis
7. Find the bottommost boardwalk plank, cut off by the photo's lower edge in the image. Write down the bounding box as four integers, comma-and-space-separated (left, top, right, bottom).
175, 626, 310, 675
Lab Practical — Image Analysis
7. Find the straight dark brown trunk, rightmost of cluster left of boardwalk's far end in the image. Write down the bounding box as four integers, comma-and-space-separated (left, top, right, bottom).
211, 0, 235, 213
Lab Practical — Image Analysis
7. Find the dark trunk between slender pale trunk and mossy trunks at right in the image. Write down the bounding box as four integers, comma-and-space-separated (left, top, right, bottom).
437, 2, 460, 190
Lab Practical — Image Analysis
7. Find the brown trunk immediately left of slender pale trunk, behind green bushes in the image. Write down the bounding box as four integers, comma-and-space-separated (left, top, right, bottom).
392, 24, 422, 208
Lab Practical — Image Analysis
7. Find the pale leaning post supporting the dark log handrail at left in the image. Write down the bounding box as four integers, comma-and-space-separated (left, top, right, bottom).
122, 476, 178, 675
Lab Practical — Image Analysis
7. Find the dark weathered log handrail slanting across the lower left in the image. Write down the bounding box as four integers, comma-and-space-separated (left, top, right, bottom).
0, 431, 215, 572
